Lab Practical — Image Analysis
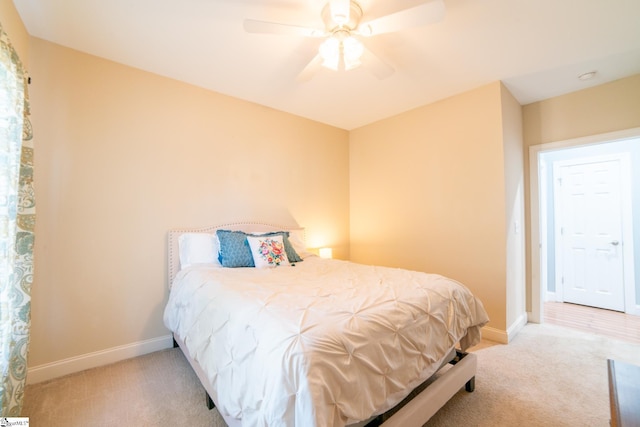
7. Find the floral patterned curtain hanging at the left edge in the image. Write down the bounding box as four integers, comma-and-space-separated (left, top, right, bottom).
0, 20, 35, 417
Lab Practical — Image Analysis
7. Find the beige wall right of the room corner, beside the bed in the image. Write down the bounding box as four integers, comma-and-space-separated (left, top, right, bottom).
350, 82, 521, 331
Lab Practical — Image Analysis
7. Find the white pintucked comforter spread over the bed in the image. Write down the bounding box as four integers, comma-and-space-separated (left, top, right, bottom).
164, 257, 488, 427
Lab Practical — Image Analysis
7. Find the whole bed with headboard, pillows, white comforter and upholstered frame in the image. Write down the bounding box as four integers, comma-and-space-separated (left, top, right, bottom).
164, 223, 488, 426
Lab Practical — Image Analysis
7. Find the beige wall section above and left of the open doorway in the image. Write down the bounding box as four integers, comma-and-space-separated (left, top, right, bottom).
523, 75, 640, 311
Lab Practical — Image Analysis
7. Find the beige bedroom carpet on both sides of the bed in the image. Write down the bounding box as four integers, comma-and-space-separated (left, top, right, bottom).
23, 324, 640, 427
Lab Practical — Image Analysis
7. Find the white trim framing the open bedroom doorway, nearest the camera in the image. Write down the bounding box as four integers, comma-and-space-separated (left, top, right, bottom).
528, 127, 640, 323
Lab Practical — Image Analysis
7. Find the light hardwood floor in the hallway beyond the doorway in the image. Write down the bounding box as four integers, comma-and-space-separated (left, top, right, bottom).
544, 302, 640, 344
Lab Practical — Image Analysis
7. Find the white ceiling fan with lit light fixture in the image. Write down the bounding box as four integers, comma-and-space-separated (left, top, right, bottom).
244, 0, 444, 81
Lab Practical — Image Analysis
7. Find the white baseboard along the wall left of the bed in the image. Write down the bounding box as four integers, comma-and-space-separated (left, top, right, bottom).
27, 335, 173, 384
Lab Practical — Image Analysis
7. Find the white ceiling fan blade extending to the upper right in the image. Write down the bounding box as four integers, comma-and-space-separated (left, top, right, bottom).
358, 0, 445, 36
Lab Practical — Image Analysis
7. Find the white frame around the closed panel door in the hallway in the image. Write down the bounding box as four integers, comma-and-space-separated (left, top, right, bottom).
552, 152, 636, 313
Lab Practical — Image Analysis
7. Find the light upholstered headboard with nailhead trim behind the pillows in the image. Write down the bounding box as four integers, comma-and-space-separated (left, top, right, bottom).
167, 222, 305, 288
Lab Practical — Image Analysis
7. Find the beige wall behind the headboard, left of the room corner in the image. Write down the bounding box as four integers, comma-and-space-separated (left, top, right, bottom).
29, 38, 349, 367
